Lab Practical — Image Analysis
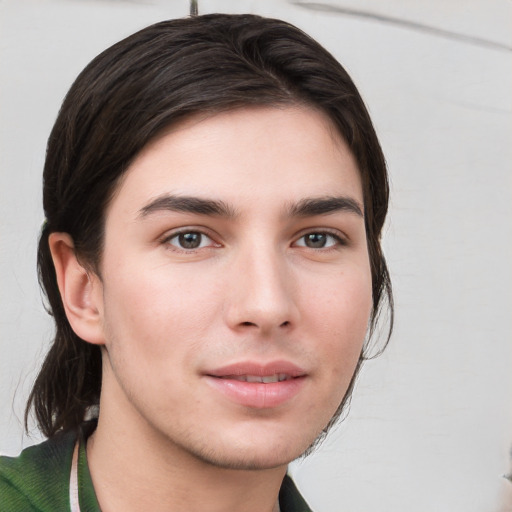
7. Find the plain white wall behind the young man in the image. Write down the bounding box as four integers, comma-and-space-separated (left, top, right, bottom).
0, 0, 512, 512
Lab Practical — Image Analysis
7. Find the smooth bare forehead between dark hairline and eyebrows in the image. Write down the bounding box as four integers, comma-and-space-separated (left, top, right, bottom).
106, 107, 362, 215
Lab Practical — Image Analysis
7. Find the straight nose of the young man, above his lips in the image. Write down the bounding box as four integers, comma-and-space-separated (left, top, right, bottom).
226, 247, 299, 335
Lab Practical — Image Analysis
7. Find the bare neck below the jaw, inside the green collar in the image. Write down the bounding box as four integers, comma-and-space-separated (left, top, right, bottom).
87, 374, 286, 512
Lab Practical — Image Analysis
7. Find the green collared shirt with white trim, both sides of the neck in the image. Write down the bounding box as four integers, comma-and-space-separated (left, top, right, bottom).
0, 422, 311, 512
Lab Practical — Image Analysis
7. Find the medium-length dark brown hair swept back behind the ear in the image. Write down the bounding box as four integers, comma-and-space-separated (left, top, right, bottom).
25, 14, 392, 437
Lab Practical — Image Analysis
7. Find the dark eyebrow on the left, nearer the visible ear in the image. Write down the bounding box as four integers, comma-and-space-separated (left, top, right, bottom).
139, 194, 237, 218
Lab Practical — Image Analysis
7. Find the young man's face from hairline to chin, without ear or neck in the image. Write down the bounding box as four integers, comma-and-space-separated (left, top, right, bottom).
93, 108, 371, 468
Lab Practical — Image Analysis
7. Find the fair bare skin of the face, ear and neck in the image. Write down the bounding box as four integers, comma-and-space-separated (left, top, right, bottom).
50, 107, 372, 512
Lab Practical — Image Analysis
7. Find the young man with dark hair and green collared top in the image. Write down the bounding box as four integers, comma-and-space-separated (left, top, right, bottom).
0, 15, 391, 512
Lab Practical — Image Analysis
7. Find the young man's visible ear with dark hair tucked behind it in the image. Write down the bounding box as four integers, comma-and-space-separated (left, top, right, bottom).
48, 233, 105, 345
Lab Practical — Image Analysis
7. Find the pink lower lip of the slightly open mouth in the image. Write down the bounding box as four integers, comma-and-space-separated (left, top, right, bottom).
206, 376, 305, 409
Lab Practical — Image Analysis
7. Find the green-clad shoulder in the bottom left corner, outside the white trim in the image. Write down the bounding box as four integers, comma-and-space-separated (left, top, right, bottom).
0, 432, 76, 512
